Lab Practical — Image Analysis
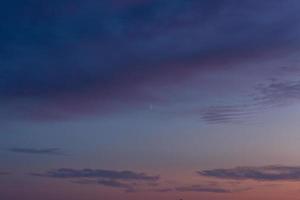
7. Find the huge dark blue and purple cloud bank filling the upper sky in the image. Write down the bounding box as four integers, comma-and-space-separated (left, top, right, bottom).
0, 0, 300, 122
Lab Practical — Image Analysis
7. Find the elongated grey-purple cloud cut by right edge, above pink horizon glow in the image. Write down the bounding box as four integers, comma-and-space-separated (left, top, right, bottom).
198, 166, 300, 181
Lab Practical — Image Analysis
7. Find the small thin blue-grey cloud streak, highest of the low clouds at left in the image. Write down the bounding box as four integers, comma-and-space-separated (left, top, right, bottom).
9, 148, 63, 155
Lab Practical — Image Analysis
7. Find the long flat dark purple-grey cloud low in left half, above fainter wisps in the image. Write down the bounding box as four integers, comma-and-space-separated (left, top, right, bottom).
33, 168, 159, 181
